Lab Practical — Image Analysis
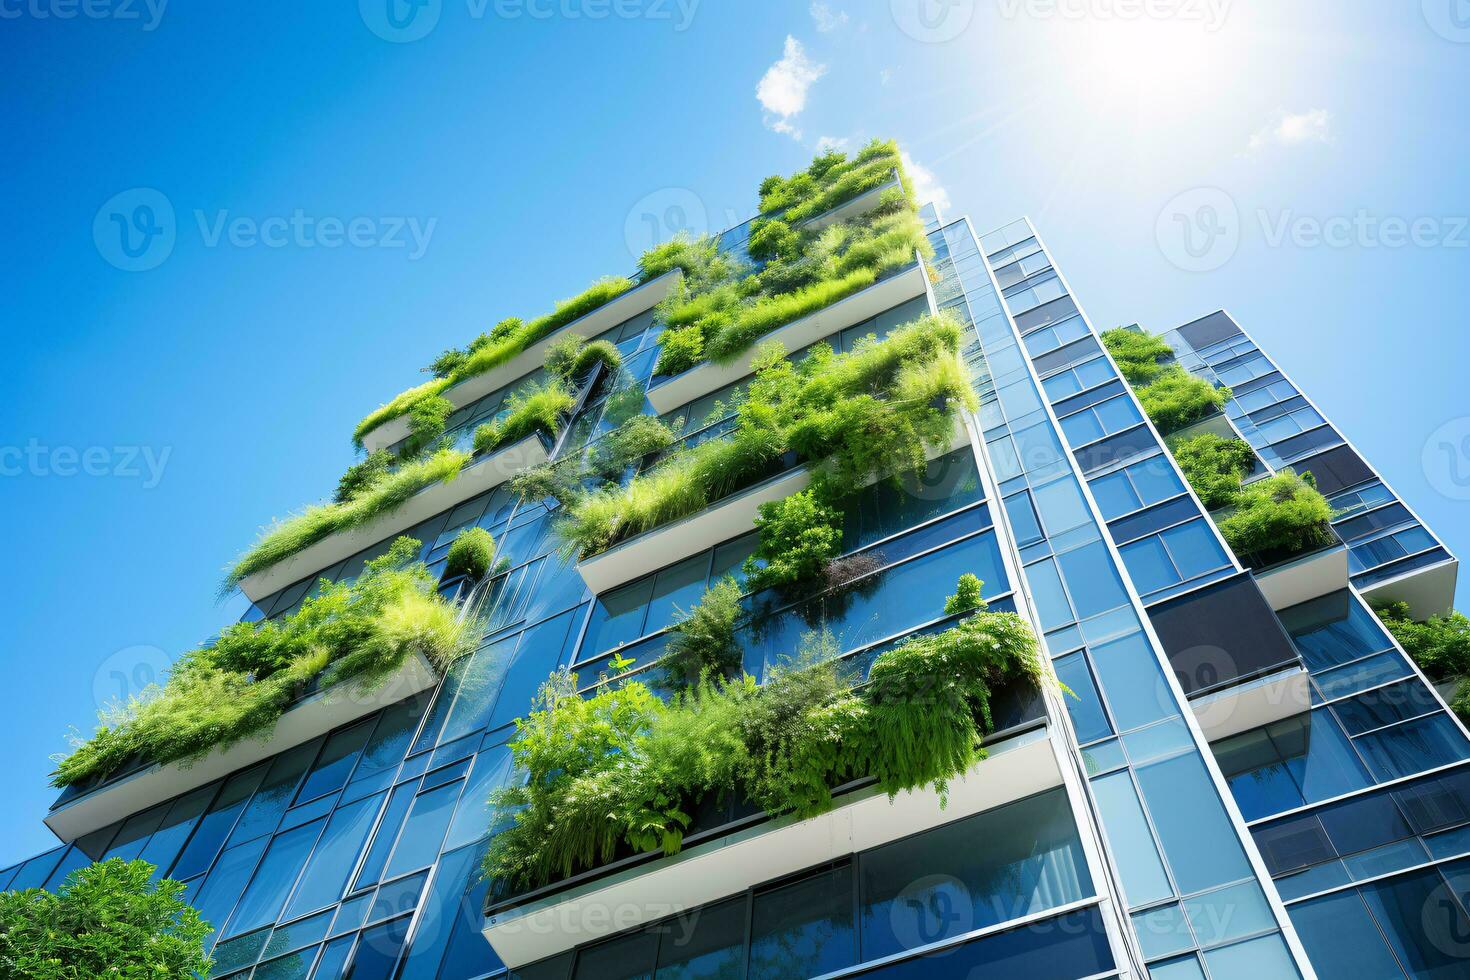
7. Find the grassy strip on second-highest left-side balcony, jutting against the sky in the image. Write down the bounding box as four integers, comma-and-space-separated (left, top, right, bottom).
221, 450, 469, 592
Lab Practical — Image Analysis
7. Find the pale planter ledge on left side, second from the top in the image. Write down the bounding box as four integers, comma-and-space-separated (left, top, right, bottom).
240, 433, 547, 602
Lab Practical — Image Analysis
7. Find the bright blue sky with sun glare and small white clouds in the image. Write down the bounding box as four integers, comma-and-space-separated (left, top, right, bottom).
0, 0, 1470, 862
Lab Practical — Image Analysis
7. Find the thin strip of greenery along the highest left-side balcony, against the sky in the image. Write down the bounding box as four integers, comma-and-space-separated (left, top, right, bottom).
353, 278, 635, 445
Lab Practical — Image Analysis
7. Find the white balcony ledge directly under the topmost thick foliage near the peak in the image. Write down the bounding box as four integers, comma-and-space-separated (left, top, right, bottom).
648, 262, 929, 414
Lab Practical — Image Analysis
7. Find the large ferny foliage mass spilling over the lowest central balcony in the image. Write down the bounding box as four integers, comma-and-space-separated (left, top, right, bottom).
485, 578, 1045, 889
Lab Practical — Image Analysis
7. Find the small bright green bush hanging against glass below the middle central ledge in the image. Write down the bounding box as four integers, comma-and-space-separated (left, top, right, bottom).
745, 489, 842, 592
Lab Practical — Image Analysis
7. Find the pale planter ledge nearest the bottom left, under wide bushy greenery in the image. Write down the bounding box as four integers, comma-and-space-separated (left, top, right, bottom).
46, 654, 440, 842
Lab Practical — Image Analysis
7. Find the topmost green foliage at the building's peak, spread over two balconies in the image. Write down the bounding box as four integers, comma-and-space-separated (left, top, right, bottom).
654, 143, 932, 375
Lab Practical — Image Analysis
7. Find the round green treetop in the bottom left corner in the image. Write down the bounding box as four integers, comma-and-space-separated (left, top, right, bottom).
0, 858, 212, 980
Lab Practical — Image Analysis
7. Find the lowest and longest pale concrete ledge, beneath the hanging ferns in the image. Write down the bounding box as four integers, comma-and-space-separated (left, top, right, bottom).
484, 730, 1061, 968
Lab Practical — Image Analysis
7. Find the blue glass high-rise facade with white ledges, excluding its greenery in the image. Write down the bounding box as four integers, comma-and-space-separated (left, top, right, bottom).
0, 185, 1470, 980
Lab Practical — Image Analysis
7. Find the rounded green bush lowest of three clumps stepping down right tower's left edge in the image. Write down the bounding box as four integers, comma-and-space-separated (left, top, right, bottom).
1220, 470, 1336, 566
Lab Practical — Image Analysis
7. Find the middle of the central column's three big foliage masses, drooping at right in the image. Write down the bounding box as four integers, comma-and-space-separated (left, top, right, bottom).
557, 316, 976, 557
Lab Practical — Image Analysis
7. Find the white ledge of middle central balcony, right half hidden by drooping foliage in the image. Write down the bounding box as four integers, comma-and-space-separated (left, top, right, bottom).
576, 413, 970, 595
